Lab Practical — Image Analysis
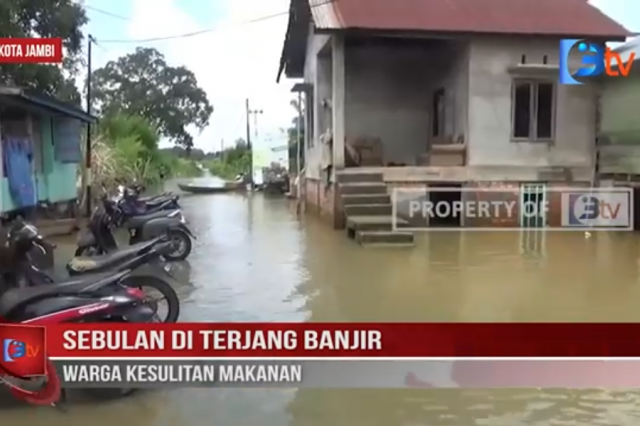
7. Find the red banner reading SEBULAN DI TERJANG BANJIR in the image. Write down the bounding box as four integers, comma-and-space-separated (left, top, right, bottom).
10, 323, 640, 358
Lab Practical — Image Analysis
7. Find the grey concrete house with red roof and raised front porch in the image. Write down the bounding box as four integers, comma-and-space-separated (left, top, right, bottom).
278, 0, 630, 243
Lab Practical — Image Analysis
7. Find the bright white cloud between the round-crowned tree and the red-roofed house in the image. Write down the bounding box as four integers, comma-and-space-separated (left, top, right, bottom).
120, 0, 294, 150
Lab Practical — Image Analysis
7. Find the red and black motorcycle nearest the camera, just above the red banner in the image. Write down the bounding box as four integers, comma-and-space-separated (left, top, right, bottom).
0, 222, 180, 398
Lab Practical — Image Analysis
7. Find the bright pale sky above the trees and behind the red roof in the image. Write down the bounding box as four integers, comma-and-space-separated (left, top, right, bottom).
80, 0, 640, 151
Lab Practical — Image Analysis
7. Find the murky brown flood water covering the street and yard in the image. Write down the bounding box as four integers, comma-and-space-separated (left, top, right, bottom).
0, 179, 640, 426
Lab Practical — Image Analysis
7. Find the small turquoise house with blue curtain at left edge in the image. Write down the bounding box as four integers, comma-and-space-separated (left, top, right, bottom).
0, 87, 96, 215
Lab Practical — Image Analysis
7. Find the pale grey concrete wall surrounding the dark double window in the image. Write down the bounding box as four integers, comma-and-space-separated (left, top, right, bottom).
468, 37, 597, 168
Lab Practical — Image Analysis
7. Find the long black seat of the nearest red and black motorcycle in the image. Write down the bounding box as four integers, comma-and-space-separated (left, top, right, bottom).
0, 271, 129, 316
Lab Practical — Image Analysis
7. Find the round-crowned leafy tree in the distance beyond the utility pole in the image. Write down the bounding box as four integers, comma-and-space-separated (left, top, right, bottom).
92, 48, 213, 150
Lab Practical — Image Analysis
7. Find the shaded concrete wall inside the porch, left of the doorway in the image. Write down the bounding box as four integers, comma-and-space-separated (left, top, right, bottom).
345, 41, 468, 165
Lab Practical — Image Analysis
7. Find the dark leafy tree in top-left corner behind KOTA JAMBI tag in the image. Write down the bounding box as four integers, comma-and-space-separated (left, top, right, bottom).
0, 0, 88, 103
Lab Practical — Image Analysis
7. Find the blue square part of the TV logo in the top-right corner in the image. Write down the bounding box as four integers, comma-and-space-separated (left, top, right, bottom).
560, 39, 606, 85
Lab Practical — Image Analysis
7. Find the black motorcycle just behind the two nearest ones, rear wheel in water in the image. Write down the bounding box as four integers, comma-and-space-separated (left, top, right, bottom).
75, 198, 195, 261
